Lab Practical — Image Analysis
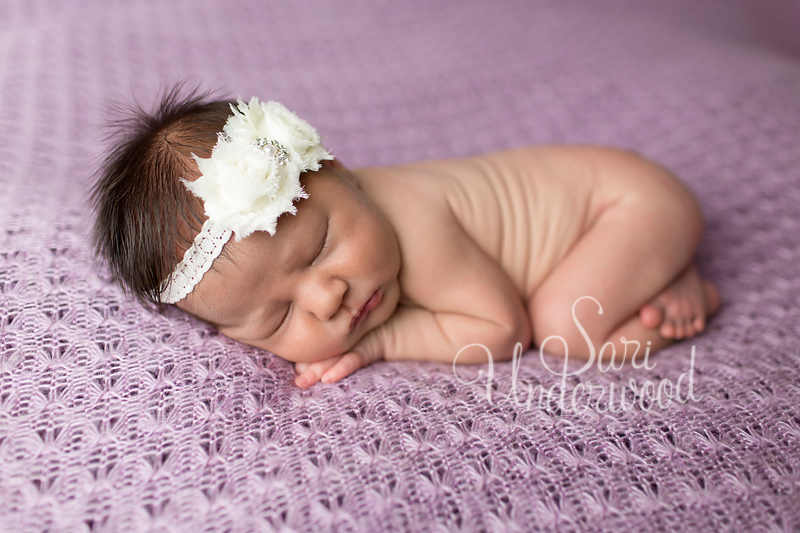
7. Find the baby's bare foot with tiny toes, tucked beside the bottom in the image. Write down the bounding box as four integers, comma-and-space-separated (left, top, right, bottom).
639, 265, 720, 339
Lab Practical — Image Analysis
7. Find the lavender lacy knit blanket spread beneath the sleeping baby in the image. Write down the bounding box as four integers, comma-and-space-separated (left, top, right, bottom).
0, 0, 800, 532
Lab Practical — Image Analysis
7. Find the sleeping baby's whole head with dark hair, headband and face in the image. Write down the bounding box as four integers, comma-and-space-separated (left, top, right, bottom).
93, 91, 400, 362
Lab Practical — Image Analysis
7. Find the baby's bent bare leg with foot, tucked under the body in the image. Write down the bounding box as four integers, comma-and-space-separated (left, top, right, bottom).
528, 152, 718, 361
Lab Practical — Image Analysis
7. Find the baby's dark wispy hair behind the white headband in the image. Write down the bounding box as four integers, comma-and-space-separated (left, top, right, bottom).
91, 85, 232, 309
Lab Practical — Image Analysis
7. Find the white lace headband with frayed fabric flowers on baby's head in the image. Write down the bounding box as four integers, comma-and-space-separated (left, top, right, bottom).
160, 97, 333, 304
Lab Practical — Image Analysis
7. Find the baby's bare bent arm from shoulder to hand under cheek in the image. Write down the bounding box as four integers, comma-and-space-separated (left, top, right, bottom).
296, 188, 531, 387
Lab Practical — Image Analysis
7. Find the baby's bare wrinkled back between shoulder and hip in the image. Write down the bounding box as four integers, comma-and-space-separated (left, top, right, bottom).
355, 147, 601, 298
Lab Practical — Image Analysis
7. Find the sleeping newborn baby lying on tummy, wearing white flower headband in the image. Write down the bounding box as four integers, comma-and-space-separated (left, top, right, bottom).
93, 90, 719, 387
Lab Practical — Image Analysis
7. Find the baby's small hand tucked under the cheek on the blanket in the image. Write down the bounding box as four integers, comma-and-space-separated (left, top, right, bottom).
294, 330, 383, 389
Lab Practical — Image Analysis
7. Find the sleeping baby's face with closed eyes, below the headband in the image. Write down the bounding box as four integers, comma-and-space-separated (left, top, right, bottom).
178, 164, 400, 362
